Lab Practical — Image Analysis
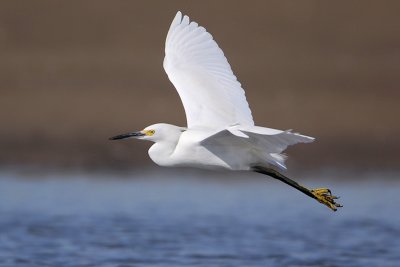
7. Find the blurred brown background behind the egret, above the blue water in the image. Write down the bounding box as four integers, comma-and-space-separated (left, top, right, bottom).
0, 0, 400, 173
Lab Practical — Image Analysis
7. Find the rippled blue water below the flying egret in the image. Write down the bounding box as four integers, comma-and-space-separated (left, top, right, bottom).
0, 172, 400, 267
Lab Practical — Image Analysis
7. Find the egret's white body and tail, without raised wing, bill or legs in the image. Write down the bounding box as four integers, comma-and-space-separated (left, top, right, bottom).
148, 123, 313, 171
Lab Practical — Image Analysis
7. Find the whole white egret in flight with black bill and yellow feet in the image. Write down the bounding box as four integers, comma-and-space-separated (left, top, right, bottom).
110, 12, 340, 211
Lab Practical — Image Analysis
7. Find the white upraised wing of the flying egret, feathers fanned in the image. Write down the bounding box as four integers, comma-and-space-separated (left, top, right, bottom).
164, 12, 254, 129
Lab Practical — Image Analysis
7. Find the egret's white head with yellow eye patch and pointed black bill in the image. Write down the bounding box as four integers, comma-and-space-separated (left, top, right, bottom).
110, 123, 186, 142
